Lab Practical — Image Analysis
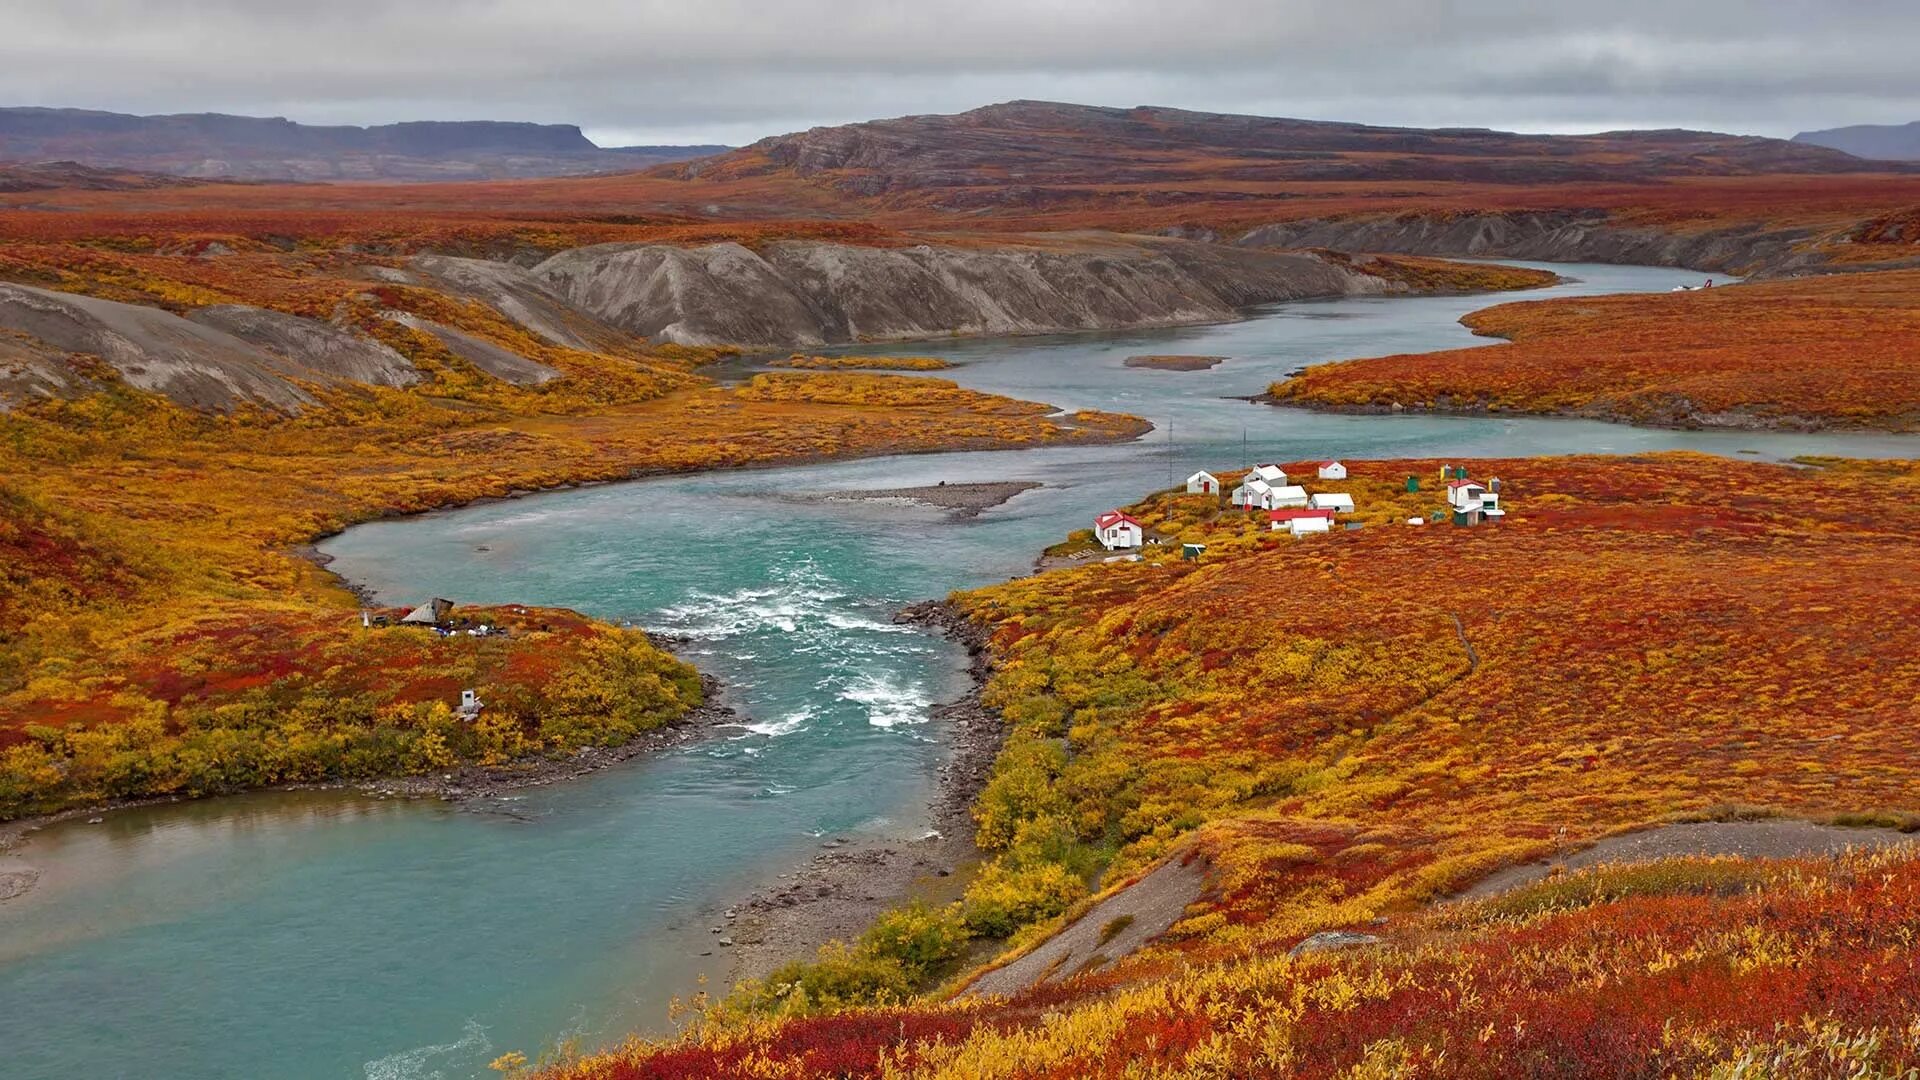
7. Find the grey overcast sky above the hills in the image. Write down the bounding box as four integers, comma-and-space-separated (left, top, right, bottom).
0, 0, 1920, 146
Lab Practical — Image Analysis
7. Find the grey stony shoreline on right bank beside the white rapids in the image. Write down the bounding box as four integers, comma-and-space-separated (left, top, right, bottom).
703, 601, 1006, 982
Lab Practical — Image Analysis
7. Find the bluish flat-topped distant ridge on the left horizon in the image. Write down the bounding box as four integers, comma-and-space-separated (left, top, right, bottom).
0, 108, 726, 181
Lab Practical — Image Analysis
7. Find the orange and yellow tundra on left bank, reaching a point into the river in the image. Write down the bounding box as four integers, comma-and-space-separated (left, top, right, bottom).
0, 226, 1142, 819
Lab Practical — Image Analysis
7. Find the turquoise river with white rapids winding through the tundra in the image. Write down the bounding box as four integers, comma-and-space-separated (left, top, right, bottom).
0, 265, 1920, 1080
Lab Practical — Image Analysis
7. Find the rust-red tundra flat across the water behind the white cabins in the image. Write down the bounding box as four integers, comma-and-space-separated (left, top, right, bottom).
1273, 271, 1920, 430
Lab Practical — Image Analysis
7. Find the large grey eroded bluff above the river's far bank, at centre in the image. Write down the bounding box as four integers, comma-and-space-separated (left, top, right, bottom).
534, 236, 1400, 348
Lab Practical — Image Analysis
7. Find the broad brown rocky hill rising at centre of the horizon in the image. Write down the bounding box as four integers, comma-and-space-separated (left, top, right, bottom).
662, 102, 1862, 199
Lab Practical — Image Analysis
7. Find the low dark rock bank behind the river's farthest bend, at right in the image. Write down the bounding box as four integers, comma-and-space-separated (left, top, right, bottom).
1236, 209, 1850, 277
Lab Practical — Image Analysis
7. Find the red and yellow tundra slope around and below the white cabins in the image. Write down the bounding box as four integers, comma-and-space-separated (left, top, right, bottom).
549, 454, 1920, 1080
